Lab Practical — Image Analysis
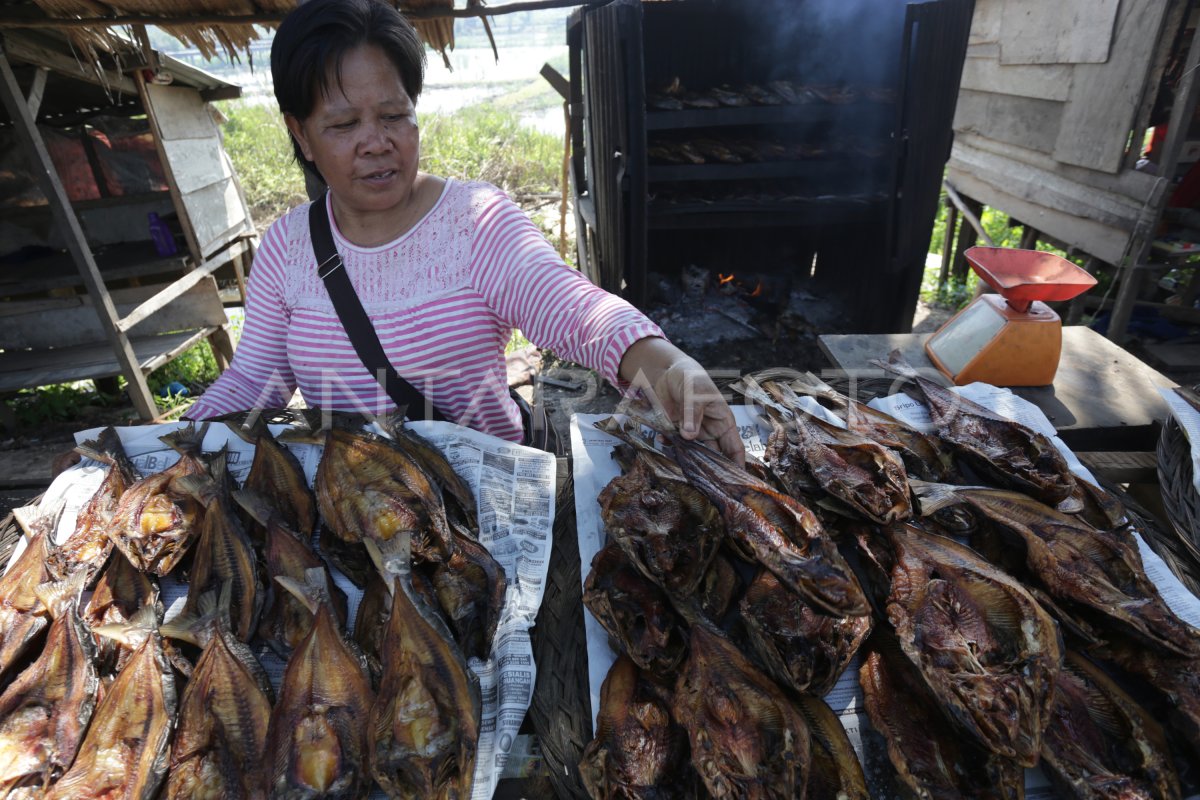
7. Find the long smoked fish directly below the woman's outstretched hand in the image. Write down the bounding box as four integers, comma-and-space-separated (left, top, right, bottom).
604, 417, 870, 616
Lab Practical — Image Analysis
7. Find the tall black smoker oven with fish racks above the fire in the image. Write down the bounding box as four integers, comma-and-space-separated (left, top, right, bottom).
568, 0, 973, 332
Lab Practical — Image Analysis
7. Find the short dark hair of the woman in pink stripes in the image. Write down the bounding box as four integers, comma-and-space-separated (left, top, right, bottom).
271, 0, 425, 174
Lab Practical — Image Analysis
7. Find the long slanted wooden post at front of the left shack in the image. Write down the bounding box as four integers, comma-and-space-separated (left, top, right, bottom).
0, 38, 157, 420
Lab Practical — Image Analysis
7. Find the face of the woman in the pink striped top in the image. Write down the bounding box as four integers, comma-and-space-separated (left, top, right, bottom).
284, 44, 420, 215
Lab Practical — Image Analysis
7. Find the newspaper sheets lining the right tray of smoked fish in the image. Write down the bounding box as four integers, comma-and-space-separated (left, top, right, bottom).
571, 384, 1200, 800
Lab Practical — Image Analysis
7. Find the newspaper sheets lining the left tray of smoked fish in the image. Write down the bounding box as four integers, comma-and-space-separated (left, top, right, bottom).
8, 421, 556, 800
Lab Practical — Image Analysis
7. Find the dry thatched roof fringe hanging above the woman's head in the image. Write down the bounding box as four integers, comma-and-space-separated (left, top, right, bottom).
0, 0, 588, 65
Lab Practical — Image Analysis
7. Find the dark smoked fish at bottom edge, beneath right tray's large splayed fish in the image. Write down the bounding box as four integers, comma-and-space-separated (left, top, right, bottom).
858, 633, 1025, 800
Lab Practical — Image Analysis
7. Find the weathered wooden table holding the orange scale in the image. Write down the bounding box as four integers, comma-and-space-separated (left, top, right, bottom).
818, 326, 1178, 451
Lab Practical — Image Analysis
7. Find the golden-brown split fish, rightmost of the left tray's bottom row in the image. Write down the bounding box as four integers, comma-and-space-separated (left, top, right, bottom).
367, 542, 482, 800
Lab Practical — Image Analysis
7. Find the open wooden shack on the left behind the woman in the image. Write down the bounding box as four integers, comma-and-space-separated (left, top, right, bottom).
0, 29, 256, 419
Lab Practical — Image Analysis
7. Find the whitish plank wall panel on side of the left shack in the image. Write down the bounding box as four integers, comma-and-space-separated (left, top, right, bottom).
146, 84, 253, 260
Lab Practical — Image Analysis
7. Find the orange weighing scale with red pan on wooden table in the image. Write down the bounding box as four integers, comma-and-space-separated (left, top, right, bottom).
925, 247, 1096, 386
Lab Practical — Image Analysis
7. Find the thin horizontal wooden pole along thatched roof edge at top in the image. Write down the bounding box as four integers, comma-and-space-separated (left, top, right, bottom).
0, 0, 607, 27
